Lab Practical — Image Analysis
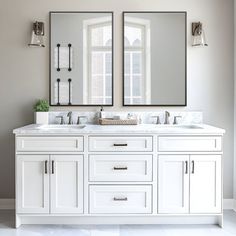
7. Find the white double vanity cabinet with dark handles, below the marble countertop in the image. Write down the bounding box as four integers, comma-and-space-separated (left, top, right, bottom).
13, 126, 223, 226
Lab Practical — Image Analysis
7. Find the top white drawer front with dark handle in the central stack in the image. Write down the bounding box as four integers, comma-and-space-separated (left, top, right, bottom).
89, 136, 152, 152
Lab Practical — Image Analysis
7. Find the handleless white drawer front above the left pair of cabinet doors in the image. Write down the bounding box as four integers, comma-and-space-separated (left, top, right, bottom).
16, 137, 84, 152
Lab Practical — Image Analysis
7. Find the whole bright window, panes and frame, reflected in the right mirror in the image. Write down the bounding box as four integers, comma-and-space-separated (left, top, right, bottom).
124, 17, 151, 104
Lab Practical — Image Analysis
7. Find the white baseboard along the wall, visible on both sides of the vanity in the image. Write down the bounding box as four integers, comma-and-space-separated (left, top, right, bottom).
0, 198, 236, 211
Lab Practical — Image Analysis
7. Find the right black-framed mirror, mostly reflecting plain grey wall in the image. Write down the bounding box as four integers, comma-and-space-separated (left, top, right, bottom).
123, 12, 187, 106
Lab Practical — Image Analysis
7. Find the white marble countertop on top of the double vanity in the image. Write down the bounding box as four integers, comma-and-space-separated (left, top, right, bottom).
13, 124, 225, 136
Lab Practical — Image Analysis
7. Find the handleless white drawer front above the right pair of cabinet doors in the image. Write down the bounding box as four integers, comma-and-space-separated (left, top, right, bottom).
158, 136, 222, 152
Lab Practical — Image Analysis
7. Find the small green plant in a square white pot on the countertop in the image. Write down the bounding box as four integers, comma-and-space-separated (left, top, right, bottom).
34, 99, 49, 124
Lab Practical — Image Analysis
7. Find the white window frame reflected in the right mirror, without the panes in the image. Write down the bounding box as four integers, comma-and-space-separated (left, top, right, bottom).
124, 16, 151, 104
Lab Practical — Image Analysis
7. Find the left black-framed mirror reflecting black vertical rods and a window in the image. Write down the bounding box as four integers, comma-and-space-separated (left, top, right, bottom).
50, 12, 113, 106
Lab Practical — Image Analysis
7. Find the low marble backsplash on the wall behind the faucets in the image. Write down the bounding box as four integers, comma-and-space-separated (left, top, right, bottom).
49, 111, 203, 124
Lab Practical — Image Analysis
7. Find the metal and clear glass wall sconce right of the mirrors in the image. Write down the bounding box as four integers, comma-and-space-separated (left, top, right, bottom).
192, 22, 208, 47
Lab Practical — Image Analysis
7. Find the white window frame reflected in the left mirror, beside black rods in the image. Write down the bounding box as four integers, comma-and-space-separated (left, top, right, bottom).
83, 17, 112, 104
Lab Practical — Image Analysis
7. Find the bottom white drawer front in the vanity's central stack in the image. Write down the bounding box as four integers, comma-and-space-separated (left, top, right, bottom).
89, 185, 152, 214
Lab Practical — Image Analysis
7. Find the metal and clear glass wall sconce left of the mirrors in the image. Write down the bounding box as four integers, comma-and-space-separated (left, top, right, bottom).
28, 21, 45, 47
